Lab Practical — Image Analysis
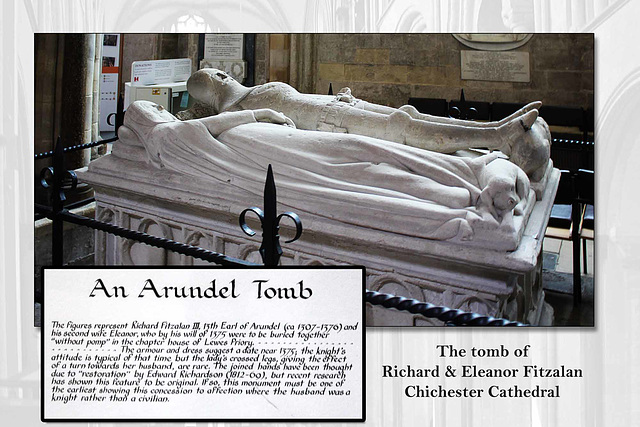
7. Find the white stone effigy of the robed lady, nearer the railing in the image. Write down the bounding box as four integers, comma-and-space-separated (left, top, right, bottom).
119, 101, 535, 250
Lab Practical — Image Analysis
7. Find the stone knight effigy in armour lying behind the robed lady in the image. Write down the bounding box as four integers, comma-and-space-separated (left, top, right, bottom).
184, 68, 551, 181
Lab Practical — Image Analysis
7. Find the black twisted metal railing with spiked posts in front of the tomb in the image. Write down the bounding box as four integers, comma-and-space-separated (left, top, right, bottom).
35, 138, 526, 326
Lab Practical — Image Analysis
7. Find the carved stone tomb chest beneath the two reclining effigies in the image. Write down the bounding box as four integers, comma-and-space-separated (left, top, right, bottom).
81, 156, 558, 326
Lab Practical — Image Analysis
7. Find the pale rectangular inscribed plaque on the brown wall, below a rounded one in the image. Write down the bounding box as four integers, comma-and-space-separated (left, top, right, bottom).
460, 50, 531, 83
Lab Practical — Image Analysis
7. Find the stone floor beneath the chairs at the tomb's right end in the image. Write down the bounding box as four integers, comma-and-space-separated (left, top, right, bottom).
543, 237, 594, 326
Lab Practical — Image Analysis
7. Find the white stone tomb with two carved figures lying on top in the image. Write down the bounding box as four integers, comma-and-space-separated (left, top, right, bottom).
81, 70, 559, 326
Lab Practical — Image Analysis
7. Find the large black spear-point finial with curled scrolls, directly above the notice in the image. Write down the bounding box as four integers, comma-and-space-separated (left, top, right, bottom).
239, 165, 302, 266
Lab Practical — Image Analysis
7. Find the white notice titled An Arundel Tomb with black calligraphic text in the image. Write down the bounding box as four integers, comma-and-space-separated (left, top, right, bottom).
42, 267, 364, 421
